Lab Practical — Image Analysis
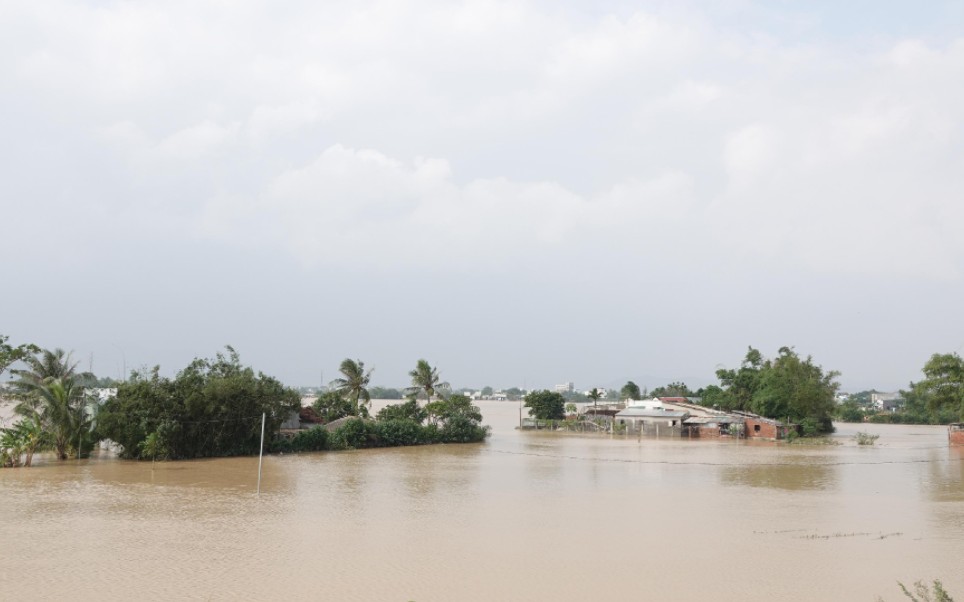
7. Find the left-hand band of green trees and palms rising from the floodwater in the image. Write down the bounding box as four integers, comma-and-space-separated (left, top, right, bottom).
0, 335, 488, 466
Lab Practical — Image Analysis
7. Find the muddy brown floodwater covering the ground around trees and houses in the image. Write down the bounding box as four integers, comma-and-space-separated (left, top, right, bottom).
0, 402, 964, 602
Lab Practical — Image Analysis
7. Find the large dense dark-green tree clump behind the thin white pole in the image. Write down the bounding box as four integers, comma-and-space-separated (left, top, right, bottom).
97, 347, 300, 459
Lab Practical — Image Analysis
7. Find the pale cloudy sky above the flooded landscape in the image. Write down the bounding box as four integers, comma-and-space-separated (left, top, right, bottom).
0, 0, 964, 391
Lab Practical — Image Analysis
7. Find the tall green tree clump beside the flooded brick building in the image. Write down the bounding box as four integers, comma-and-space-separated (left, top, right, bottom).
702, 347, 839, 434
